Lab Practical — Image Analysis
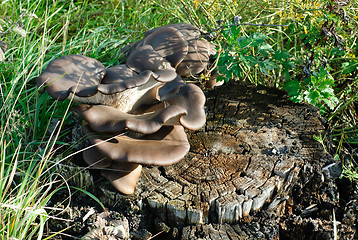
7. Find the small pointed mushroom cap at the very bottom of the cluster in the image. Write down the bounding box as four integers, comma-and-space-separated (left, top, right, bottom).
101, 162, 142, 195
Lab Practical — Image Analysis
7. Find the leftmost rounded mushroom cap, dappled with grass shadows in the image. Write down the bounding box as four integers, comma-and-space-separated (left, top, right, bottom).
37, 55, 106, 100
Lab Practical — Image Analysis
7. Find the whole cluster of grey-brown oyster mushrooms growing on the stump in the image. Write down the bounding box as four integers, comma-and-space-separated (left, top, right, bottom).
37, 24, 215, 194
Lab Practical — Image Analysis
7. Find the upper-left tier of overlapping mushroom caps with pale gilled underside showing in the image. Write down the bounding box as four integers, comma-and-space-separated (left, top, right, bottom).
37, 54, 177, 112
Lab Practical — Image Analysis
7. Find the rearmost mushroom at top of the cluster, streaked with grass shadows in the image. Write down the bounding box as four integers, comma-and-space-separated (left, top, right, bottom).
123, 23, 216, 77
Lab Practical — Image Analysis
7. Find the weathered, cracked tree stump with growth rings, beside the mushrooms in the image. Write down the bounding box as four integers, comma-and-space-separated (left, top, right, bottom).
130, 81, 329, 226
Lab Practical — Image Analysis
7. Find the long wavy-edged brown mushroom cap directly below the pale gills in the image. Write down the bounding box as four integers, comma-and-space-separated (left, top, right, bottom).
72, 104, 187, 134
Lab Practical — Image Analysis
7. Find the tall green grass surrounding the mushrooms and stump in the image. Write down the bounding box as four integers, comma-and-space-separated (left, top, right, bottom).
0, 0, 358, 239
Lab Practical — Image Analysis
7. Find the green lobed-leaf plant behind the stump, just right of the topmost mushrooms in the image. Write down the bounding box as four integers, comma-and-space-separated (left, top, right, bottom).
216, 17, 295, 84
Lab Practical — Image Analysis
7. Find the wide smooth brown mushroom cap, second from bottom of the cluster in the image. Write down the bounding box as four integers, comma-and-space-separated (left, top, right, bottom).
85, 125, 190, 166
